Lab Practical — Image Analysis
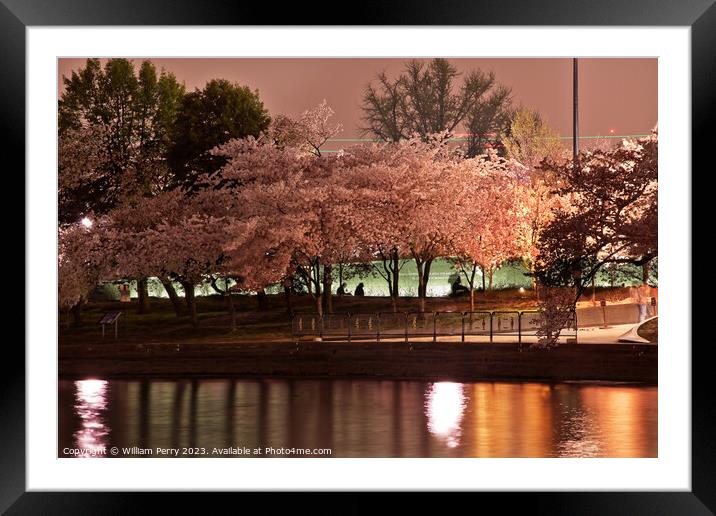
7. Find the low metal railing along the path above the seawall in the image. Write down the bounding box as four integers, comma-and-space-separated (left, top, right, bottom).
291, 310, 577, 343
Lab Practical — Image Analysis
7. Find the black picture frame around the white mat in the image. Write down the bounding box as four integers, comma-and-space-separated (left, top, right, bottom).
0, 0, 716, 515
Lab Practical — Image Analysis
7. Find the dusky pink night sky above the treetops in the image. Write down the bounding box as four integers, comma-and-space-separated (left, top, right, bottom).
58, 57, 658, 149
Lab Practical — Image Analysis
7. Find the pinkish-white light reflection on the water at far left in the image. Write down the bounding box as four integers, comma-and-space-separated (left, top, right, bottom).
74, 380, 109, 457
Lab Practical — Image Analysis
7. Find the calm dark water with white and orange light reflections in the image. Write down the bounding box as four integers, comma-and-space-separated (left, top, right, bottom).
58, 379, 657, 457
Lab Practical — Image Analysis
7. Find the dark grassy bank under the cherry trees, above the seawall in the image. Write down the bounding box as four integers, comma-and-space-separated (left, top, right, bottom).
59, 289, 548, 347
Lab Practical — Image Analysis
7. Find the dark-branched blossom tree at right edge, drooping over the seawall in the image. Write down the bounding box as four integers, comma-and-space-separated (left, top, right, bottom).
536, 132, 658, 345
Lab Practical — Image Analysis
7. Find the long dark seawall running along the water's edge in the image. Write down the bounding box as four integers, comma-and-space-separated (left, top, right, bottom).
59, 342, 658, 384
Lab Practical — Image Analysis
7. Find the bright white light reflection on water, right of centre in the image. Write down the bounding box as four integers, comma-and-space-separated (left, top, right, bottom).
425, 382, 465, 448
